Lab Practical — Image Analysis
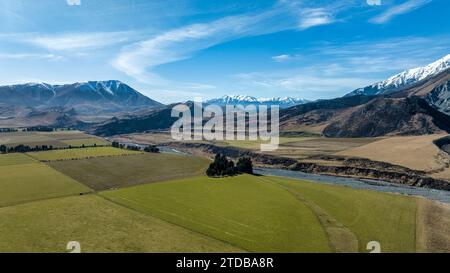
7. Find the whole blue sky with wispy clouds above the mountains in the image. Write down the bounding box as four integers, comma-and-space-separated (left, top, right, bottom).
0, 0, 450, 103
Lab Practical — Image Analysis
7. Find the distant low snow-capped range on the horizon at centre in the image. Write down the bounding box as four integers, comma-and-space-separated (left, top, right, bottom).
205, 95, 310, 108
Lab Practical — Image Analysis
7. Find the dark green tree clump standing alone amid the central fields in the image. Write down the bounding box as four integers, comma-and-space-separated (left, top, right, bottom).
206, 153, 253, 177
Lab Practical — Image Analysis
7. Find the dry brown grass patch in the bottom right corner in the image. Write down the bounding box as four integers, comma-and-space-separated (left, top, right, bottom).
416, 198, 450, 253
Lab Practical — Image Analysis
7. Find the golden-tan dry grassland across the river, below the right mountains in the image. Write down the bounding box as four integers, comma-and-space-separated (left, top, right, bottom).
337, 134, 445, 171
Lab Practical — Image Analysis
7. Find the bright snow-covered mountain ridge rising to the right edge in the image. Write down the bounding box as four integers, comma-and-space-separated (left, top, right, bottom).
346, 54, 450, 96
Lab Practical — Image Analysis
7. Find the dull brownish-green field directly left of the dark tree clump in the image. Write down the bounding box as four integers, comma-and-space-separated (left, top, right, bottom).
49, 153, 210, 191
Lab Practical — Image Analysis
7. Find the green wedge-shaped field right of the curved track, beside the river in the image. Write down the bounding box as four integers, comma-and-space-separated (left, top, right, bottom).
265, 177, 417, 252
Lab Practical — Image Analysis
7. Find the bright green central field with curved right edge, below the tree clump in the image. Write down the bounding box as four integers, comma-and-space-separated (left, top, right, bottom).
101, 175, 330, 252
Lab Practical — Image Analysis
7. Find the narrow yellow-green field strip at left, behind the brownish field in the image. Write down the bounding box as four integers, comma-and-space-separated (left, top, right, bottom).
28, 147, 142, 161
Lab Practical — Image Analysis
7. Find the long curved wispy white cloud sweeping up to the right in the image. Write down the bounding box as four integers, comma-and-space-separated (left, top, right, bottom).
113, 10, 298, 83
